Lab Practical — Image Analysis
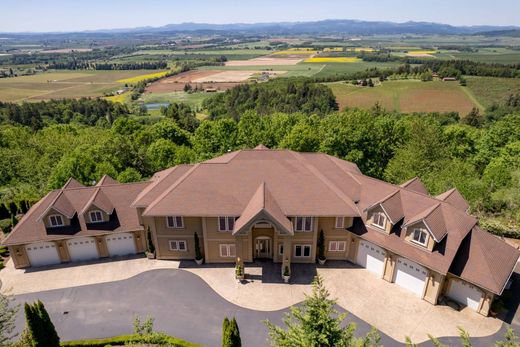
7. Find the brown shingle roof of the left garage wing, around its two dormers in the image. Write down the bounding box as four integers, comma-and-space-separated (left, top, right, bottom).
2, 182, 149, 245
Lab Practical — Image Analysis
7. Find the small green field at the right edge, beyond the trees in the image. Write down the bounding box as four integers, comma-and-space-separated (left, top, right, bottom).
466, 76, 520, 107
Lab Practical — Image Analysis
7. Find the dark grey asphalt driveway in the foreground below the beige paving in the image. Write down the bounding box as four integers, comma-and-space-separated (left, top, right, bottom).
11, 270, 516, 347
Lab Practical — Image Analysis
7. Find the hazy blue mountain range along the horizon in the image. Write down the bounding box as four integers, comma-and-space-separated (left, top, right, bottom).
4, 19, 520, 35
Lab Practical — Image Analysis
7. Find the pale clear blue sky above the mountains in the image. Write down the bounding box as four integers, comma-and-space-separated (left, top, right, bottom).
4, 0, 520, 32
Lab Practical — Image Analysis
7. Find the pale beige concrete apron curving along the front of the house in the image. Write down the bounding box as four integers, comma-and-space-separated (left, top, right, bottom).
0, 258, 502, 343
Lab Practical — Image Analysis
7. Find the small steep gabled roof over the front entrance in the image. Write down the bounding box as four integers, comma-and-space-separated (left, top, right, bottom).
233, 182, 294, 235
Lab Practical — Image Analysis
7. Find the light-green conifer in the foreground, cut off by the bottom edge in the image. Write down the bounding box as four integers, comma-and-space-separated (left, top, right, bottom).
264, 275, 380, 347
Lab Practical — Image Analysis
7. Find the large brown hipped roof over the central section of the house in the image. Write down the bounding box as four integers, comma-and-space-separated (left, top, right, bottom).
144, 149, 360, 216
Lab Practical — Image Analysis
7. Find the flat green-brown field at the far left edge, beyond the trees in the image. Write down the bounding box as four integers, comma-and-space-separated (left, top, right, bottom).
0, 70, 165, 102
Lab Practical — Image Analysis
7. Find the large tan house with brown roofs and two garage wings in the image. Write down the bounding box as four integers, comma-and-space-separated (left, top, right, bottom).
3, 145, 520, 315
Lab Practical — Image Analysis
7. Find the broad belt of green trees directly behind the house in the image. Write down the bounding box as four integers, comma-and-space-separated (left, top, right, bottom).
0, 84, 520, 237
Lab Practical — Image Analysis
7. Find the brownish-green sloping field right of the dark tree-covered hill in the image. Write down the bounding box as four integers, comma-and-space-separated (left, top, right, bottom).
327, 80, 477, 115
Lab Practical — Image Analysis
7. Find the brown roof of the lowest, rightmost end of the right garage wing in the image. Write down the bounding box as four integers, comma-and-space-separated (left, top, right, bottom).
450, 226, 520, 295
